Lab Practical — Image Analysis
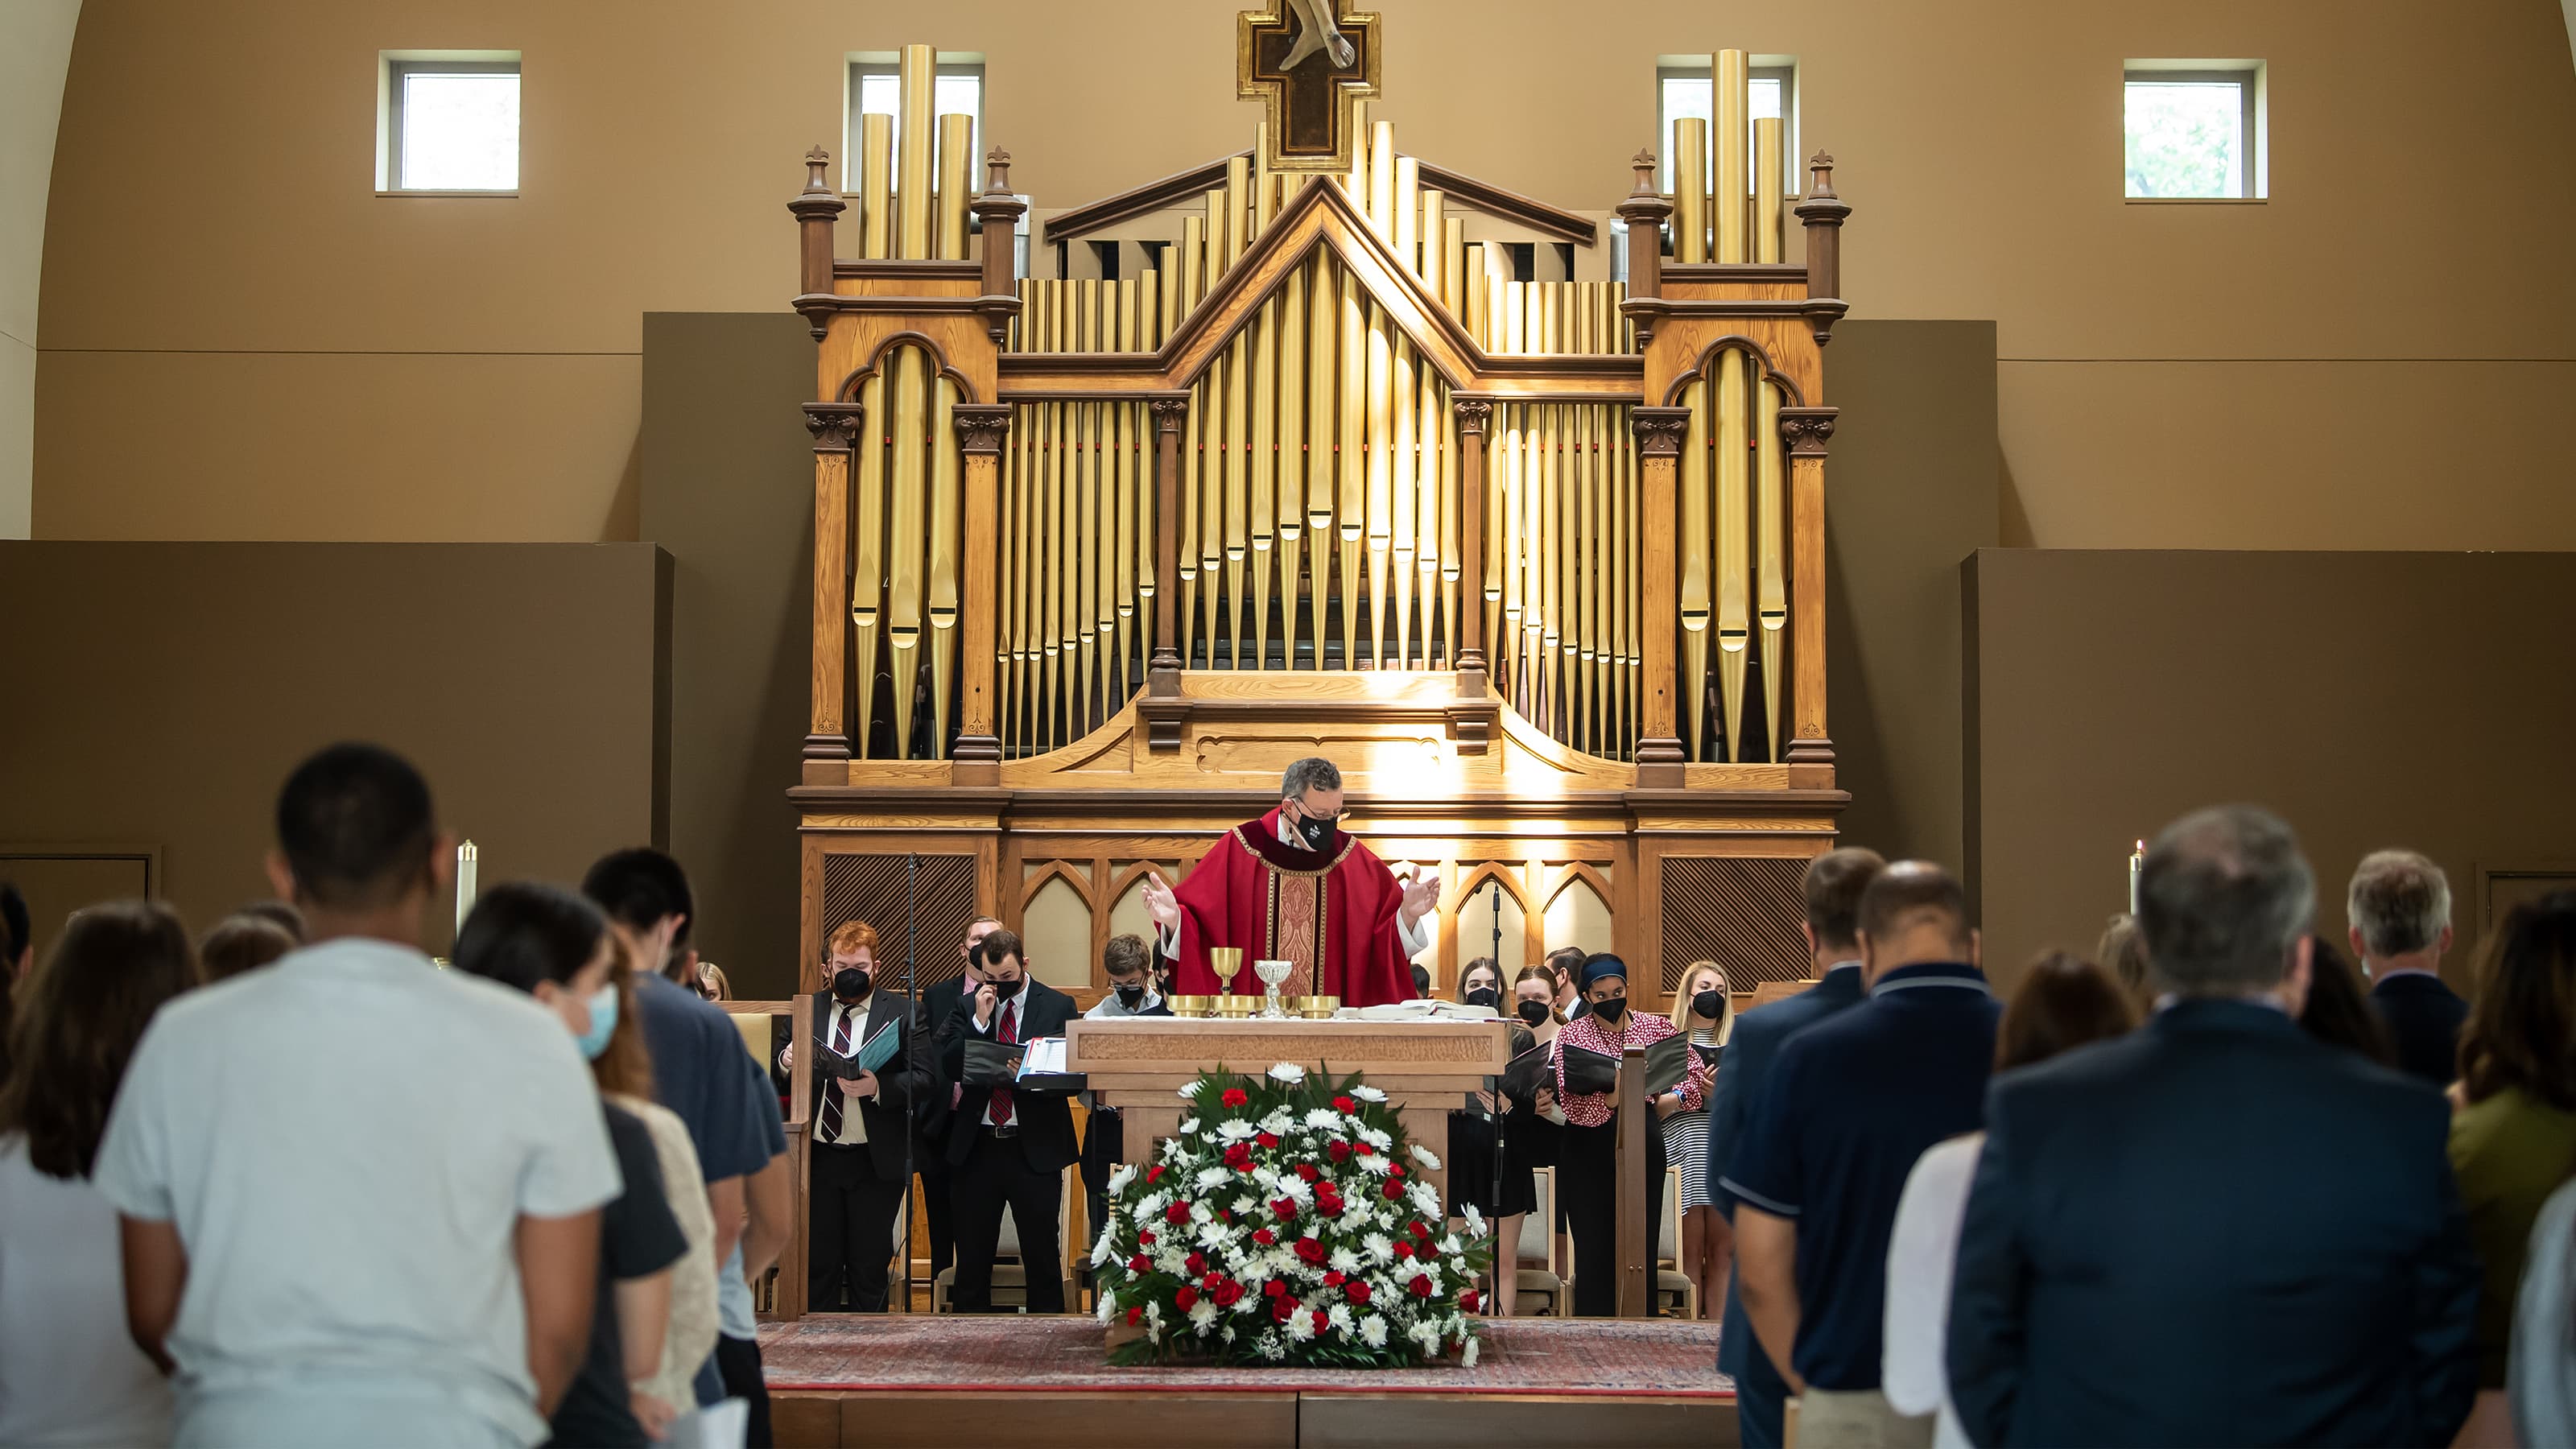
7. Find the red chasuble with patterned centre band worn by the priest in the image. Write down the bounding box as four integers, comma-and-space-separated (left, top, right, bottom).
1172, 810, 1414, 1005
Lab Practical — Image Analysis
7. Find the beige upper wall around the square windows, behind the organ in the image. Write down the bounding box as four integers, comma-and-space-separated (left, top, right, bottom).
34, 0, 2576, 549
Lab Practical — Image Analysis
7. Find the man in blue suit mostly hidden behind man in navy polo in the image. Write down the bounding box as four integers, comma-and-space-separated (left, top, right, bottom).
1708, 848, 1885, 1449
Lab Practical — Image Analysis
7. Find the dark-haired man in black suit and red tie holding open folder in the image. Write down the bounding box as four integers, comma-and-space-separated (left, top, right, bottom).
938, 931, 1080, 1312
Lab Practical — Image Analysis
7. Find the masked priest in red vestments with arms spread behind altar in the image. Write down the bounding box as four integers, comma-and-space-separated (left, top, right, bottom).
1144, 758, 1440, 1005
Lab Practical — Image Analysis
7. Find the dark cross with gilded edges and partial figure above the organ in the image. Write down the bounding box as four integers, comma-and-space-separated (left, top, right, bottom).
1234, 0, 1378, 173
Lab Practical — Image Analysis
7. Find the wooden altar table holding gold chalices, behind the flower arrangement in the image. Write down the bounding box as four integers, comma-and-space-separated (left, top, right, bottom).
1064, 1016, 1512, 1199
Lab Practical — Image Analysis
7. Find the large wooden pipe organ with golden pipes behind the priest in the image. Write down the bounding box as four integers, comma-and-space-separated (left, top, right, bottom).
788, 34, 1847, 1001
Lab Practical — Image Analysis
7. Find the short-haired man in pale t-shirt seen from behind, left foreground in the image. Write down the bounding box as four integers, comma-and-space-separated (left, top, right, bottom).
95, 745, 621, 1447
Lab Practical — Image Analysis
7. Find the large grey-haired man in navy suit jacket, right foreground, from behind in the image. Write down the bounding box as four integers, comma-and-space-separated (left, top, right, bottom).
1950, 807, 2478, 1447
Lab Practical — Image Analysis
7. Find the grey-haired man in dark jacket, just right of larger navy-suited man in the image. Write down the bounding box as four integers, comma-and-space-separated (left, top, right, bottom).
2344, 851, 2468, 1085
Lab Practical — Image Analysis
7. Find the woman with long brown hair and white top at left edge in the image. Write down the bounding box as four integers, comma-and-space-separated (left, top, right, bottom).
0, 900, 198, 1444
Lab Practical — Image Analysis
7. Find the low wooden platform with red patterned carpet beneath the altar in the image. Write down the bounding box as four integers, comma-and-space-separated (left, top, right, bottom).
760, 1315, 1736, 1449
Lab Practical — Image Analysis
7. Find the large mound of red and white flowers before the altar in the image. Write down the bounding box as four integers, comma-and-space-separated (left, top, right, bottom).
1092, 1063, 1494, 1369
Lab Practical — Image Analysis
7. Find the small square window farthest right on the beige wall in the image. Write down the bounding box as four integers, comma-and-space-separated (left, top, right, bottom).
2120, 60, 2267, 201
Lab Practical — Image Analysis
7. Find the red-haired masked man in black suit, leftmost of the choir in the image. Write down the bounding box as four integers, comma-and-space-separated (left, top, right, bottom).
778, 920, 938, 1312
